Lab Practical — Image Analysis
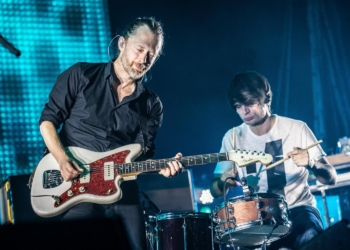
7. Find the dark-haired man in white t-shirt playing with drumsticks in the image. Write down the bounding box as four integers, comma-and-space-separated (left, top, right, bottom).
210, 71, 337, 249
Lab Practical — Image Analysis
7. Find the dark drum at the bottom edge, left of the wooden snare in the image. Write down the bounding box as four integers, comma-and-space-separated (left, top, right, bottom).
156, 213, 213, 250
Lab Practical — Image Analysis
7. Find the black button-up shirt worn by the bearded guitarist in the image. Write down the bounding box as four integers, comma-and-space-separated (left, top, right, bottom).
39, 62, 163, 158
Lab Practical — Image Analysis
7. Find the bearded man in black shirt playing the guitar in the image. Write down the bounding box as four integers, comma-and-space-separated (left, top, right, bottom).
40, 18, 182, 250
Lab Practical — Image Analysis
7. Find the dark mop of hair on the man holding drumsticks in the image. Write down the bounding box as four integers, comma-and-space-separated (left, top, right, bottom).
227, 71, 272, 109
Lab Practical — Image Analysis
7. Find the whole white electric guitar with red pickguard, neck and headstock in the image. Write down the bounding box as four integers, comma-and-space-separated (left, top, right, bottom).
31, 144, 272, 217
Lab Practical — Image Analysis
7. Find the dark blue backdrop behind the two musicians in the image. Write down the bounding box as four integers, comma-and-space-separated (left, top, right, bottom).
109, 0, 350, 210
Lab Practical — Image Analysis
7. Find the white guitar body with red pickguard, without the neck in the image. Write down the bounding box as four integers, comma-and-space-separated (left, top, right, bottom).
31, 144, 142, 217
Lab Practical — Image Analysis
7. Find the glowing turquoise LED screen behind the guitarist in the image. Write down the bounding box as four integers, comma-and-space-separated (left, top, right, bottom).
0, 0, 111, 179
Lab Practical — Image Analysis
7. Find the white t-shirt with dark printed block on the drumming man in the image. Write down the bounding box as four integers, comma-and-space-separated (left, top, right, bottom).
214, 116, 325, 208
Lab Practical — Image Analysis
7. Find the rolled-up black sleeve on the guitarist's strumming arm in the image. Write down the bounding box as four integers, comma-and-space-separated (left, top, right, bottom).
39, 63, 81, 129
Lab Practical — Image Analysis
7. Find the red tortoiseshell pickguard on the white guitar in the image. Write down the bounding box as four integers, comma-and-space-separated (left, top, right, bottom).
54, 150, 130, 207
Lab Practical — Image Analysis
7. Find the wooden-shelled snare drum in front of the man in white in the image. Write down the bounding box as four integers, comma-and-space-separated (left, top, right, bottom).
213, 193, 291, 246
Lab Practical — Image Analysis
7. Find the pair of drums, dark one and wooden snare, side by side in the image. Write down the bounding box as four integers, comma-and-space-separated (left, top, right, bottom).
146, 188, 291, 250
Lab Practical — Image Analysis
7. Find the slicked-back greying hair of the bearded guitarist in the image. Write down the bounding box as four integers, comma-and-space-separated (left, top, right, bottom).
120, 17, 164, 55
